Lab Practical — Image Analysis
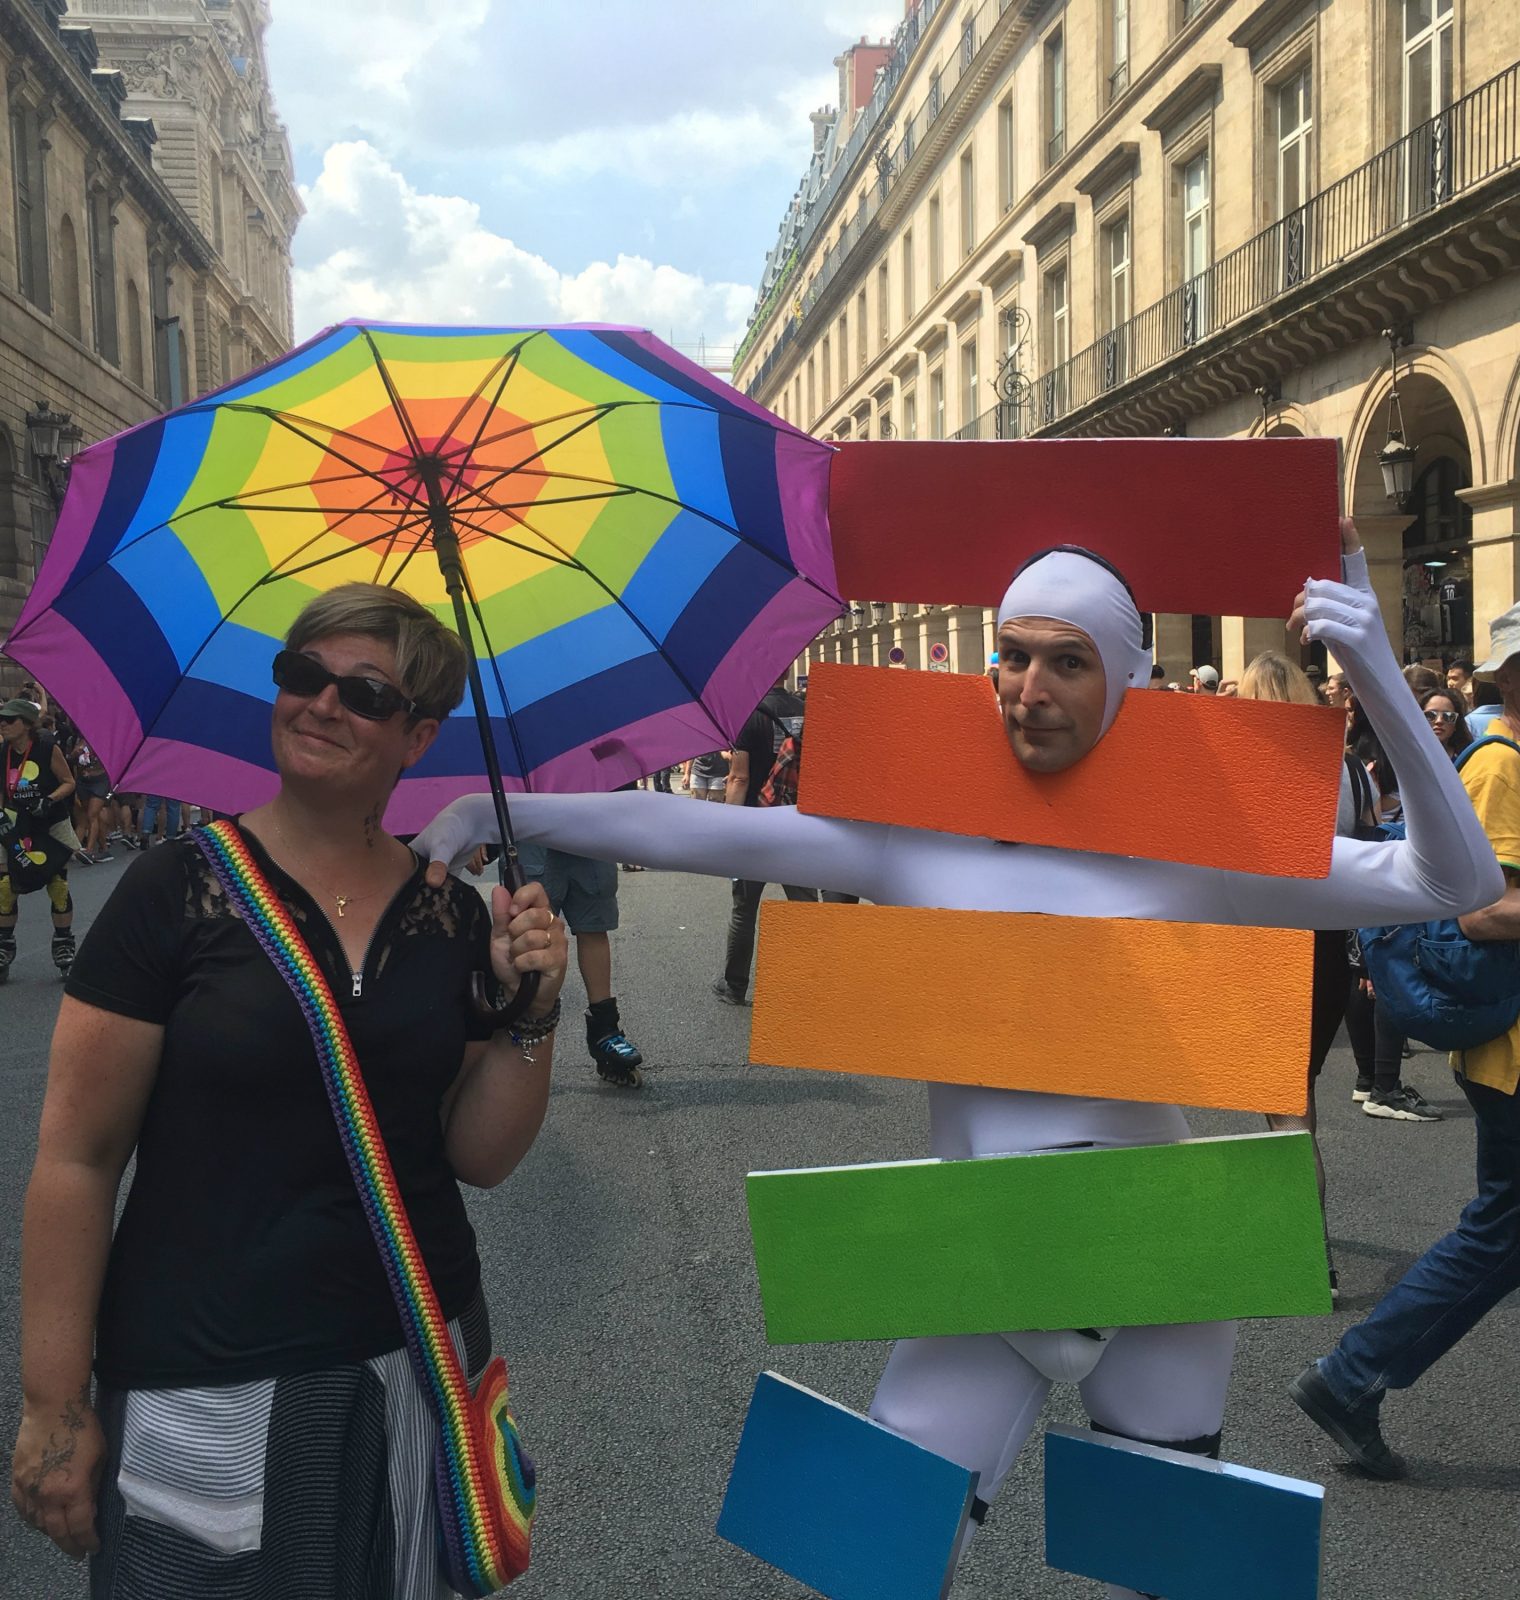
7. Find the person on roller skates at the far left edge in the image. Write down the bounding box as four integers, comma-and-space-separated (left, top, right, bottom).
0, 698, 78, 982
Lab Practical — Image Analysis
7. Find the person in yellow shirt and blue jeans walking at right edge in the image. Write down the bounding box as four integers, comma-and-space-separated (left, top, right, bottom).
1290, 605, 1520, 1478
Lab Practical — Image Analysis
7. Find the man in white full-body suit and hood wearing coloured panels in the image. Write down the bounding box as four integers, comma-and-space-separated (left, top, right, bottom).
416, 523, 1502, 1600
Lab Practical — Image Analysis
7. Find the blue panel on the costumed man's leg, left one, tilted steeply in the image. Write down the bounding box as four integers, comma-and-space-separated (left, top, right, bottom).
718, 1373, 976, 1600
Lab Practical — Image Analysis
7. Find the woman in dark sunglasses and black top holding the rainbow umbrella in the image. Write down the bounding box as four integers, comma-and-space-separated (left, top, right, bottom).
13, 584, 566, 1600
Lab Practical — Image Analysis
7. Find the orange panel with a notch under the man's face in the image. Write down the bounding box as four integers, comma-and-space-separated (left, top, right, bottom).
798, 662, 1346, 878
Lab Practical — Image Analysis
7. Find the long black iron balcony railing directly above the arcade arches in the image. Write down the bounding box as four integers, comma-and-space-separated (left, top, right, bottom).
1030, 62, 1520, 437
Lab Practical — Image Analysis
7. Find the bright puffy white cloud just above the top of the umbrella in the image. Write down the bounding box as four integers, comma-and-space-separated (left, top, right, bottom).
294, 141, 755, 346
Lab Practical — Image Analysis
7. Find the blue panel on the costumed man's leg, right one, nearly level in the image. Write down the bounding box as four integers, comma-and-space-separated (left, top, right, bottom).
1045, 1426, 1325, 1600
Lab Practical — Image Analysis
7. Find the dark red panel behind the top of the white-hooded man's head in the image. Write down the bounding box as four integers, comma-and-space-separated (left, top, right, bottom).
829, 438, 1341, 621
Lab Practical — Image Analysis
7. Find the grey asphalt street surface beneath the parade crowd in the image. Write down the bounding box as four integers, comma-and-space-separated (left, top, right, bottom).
0, 858, 1520, 1600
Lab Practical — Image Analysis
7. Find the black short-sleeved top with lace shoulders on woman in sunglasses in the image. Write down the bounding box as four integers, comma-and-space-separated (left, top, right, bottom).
67, 834, 491, 1389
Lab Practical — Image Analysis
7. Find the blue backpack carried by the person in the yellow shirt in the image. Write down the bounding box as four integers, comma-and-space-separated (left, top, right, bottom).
1357, 734, 1520, 1050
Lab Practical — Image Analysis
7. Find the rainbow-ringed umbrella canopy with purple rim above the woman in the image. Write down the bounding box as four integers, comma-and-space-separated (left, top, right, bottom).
6, 323, 840, 829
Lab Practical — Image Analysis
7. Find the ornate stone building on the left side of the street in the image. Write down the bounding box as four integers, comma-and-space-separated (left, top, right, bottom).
0, 0, 301, 690
